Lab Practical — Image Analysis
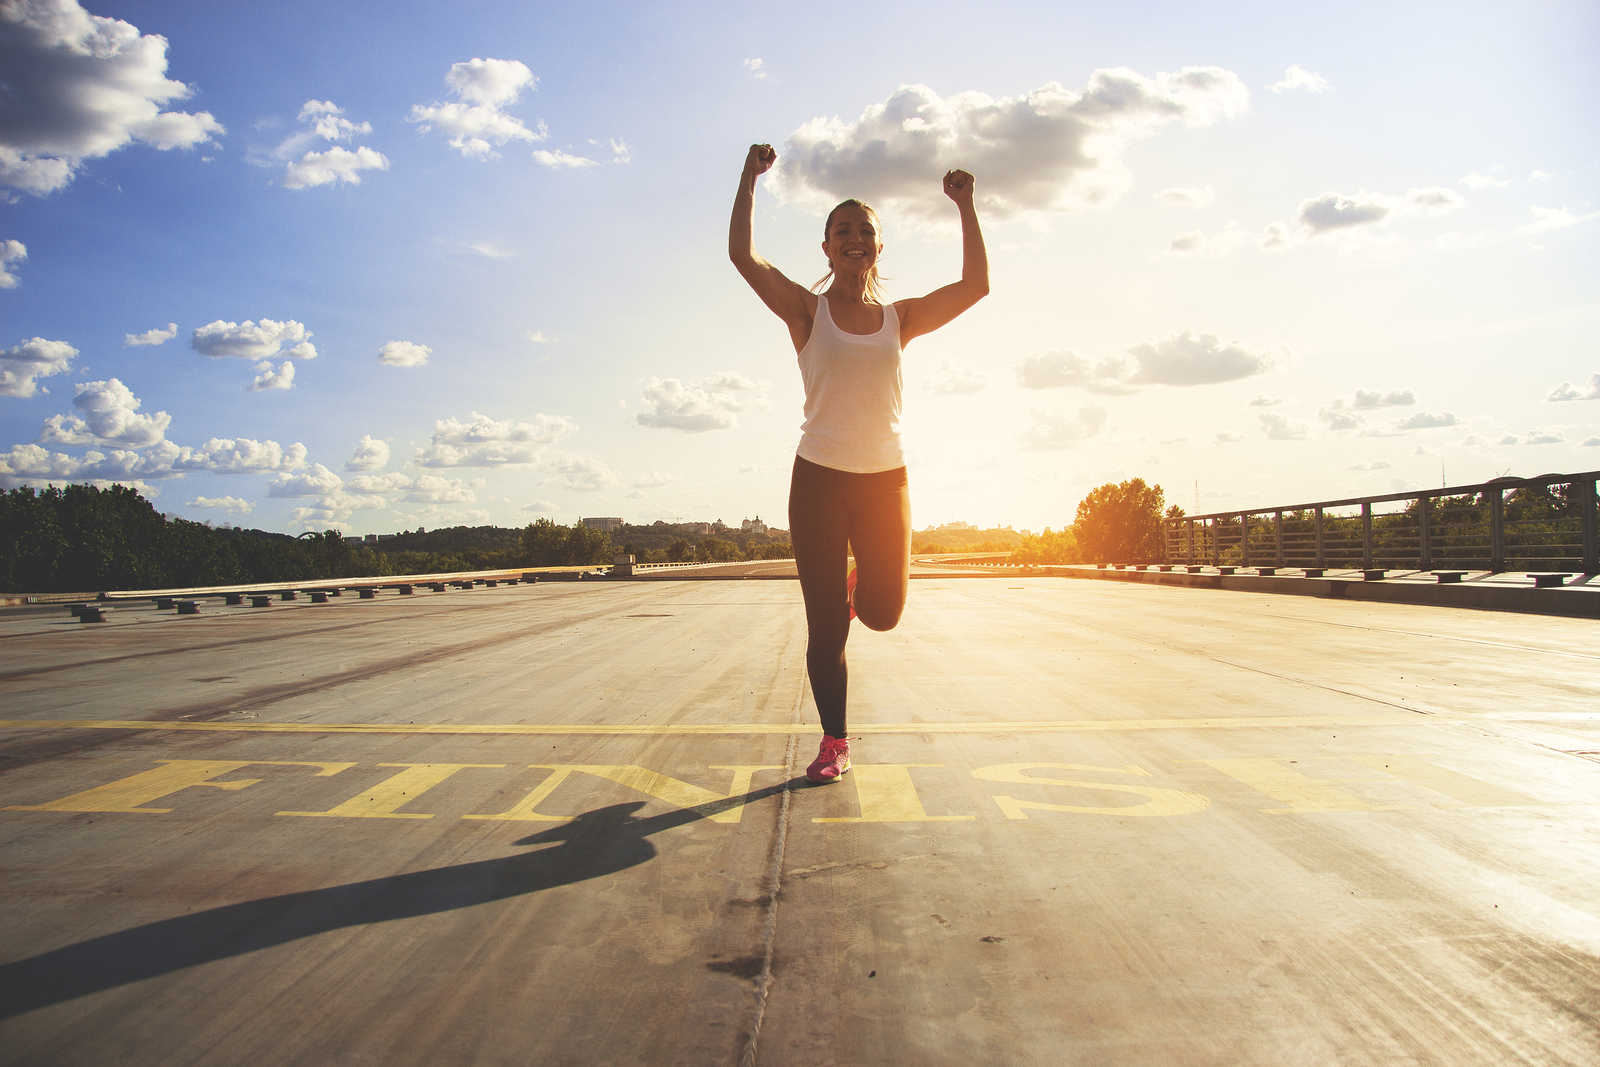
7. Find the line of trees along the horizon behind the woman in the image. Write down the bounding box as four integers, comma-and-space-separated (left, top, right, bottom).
0, 478, 1182, 593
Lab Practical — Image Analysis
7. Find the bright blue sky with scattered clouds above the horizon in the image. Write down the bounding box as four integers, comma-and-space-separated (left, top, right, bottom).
0, 0, 1600, 533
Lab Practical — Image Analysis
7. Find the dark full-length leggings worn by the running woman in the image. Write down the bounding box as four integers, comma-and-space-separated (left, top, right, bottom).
789, 456, 910, 737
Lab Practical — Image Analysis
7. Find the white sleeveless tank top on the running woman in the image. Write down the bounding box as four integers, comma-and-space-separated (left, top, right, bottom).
797, 296, 906, 474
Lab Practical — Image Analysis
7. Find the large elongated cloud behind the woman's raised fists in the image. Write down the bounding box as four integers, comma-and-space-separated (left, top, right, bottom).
768, 67, 1250, 226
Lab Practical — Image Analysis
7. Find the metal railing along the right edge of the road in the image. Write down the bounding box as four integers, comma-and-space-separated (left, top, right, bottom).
1162, 470, 1600, 574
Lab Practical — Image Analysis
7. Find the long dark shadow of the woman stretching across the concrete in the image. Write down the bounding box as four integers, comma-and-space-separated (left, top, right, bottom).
0, 782, 795, 1019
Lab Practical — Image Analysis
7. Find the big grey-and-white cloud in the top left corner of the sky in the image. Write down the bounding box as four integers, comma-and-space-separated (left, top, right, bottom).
0, 0, 227, 197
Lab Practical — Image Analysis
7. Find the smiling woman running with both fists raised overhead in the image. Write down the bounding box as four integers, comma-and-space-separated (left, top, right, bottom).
728, 144, 989, 784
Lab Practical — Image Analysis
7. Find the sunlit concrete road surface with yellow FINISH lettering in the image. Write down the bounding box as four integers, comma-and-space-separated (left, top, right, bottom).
0, 577, 1600, 1067
